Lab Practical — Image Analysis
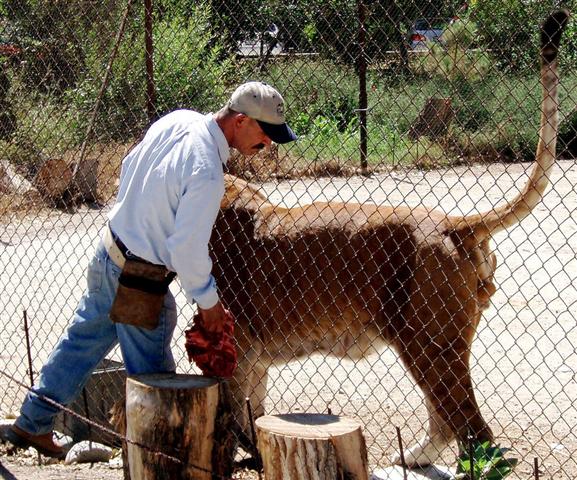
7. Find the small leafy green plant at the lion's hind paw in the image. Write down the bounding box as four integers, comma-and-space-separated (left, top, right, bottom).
455, 442, 518, 480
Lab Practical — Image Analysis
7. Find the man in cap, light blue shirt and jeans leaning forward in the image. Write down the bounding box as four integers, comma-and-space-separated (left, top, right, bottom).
5, 82, 296, 458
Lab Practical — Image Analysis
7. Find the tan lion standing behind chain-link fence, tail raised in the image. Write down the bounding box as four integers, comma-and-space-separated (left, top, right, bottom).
211, 12, 566, 465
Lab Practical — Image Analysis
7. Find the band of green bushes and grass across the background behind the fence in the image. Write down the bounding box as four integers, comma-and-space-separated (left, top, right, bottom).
0, 0, 577, 172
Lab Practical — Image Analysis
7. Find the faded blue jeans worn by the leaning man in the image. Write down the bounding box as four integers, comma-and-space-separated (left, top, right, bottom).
15, 242, 177, 434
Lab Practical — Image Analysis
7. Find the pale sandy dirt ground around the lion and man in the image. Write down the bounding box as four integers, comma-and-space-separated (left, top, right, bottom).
0, 161, 577, 480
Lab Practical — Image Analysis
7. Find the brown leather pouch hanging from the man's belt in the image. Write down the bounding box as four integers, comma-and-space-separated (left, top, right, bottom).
110, 258, 176, 330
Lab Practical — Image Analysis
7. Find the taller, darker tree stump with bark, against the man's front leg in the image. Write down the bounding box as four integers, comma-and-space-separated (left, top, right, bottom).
126, 374, 219, 480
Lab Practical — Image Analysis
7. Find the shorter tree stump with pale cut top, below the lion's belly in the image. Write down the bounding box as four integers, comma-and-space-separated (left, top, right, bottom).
255, 414, 368, 480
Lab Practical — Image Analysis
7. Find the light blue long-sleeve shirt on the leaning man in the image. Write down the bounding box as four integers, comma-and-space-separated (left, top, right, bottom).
109, 110, 230, 308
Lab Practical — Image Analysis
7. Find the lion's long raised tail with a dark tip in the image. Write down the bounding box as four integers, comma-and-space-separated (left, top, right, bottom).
454, 9, 569, 242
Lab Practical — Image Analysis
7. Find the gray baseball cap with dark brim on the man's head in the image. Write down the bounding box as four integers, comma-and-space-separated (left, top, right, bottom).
228, 82, 297, 143
